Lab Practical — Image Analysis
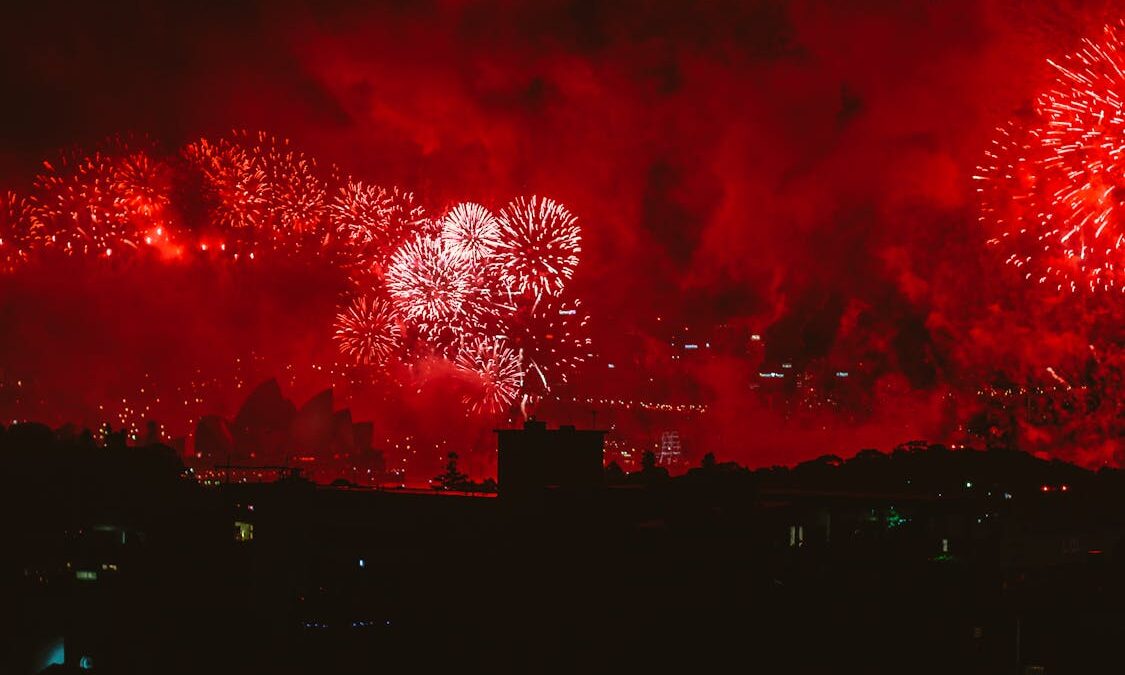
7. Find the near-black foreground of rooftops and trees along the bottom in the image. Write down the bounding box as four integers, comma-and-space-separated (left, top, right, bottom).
0, 438, 1125, 674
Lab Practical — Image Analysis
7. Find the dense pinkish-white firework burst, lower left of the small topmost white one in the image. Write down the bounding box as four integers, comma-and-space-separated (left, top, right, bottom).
386, 235, 473, 333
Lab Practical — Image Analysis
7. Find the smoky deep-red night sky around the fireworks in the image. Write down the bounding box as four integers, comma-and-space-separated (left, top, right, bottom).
0, 0, 1121, 474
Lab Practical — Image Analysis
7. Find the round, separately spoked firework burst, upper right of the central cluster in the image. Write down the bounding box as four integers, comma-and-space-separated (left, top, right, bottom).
496, 197, 582, 298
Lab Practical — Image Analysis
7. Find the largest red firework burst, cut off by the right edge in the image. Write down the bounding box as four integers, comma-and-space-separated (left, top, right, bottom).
974, 26, 1125, 291
